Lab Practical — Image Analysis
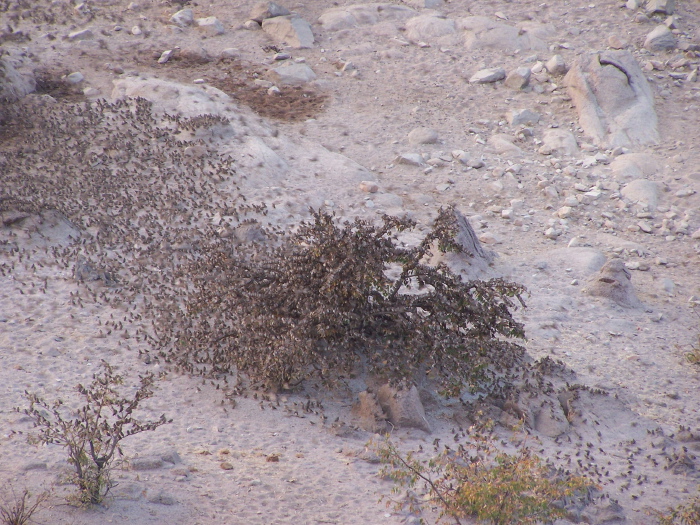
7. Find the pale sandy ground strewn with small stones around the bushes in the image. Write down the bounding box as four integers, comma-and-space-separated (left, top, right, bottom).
0, 0, 700, 525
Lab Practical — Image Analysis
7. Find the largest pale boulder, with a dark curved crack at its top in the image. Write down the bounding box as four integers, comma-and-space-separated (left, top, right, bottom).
564, 51, 659, 148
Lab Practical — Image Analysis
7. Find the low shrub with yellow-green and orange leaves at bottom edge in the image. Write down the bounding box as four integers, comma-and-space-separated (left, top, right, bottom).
378, 430, 594, 525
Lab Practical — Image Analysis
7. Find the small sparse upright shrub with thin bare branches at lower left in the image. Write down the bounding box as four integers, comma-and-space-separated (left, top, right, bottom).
17, 361, 172, 505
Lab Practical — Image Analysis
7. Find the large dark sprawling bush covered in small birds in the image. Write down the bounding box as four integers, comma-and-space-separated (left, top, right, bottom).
159, 209, 524, 395
